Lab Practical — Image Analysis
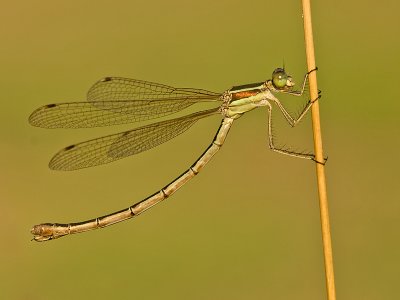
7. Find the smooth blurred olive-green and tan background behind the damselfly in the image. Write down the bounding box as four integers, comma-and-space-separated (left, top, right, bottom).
0, 0, 400, 299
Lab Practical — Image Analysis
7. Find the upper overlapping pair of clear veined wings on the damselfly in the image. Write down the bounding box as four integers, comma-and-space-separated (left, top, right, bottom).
29, 77, 221, 128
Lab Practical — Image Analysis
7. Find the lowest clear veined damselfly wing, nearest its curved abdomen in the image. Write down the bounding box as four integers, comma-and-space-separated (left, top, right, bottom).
49, 108, 219, 171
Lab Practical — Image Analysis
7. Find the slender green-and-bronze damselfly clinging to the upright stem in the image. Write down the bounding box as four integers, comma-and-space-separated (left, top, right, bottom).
29, 68, 317, 242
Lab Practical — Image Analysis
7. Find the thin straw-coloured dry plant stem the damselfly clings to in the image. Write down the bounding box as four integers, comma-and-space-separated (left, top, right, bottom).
302, 0, 336, 300
